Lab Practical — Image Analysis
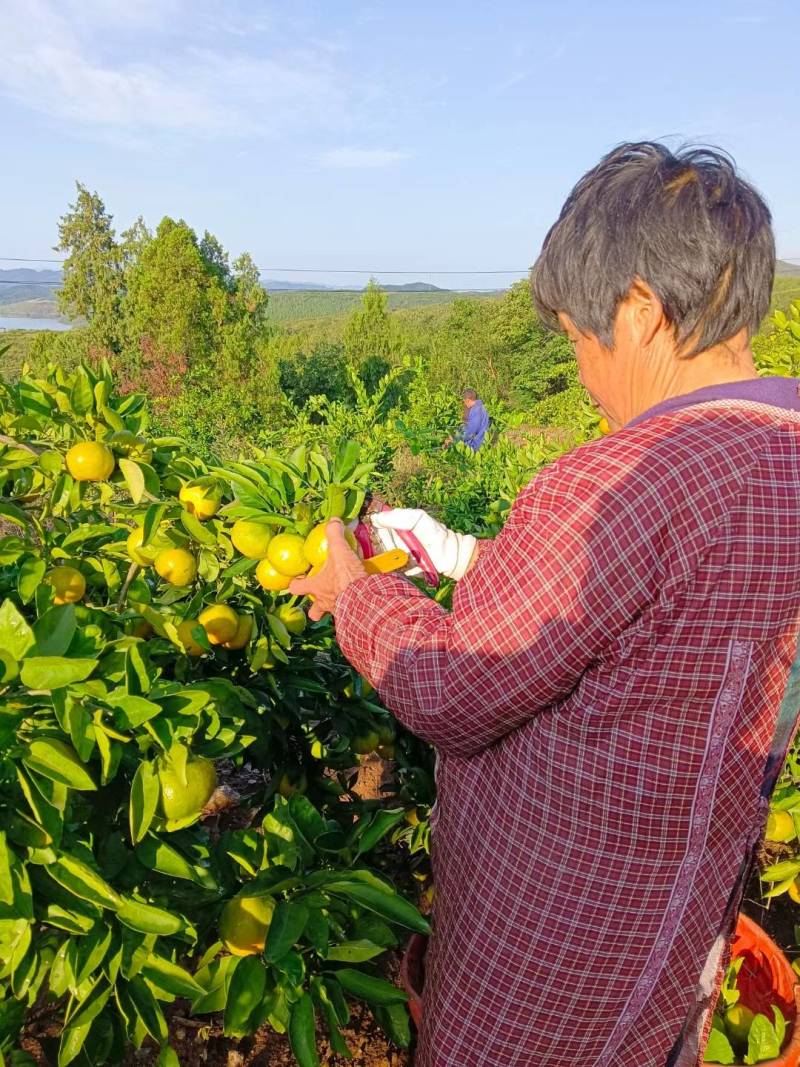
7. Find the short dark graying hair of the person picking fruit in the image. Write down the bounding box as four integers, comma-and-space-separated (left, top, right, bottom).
531, 141, 775, 355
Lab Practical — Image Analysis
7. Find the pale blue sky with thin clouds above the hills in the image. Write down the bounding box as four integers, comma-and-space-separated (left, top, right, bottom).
0, 0, 800, 287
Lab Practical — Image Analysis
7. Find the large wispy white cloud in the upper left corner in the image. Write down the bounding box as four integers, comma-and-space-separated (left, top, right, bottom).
0, 0, 349, 137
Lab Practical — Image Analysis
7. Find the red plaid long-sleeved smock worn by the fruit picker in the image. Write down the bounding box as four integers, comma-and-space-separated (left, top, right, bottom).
336, 383, 800, 1067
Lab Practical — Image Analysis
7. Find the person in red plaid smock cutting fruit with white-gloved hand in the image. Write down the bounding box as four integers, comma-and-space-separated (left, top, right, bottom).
295, 143, 800, 1067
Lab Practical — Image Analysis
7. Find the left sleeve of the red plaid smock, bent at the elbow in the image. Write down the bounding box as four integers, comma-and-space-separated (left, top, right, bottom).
336, 450, 667, 755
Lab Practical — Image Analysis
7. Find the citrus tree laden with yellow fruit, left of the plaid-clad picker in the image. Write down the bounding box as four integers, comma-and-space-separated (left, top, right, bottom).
0, 366, 427, 1067
